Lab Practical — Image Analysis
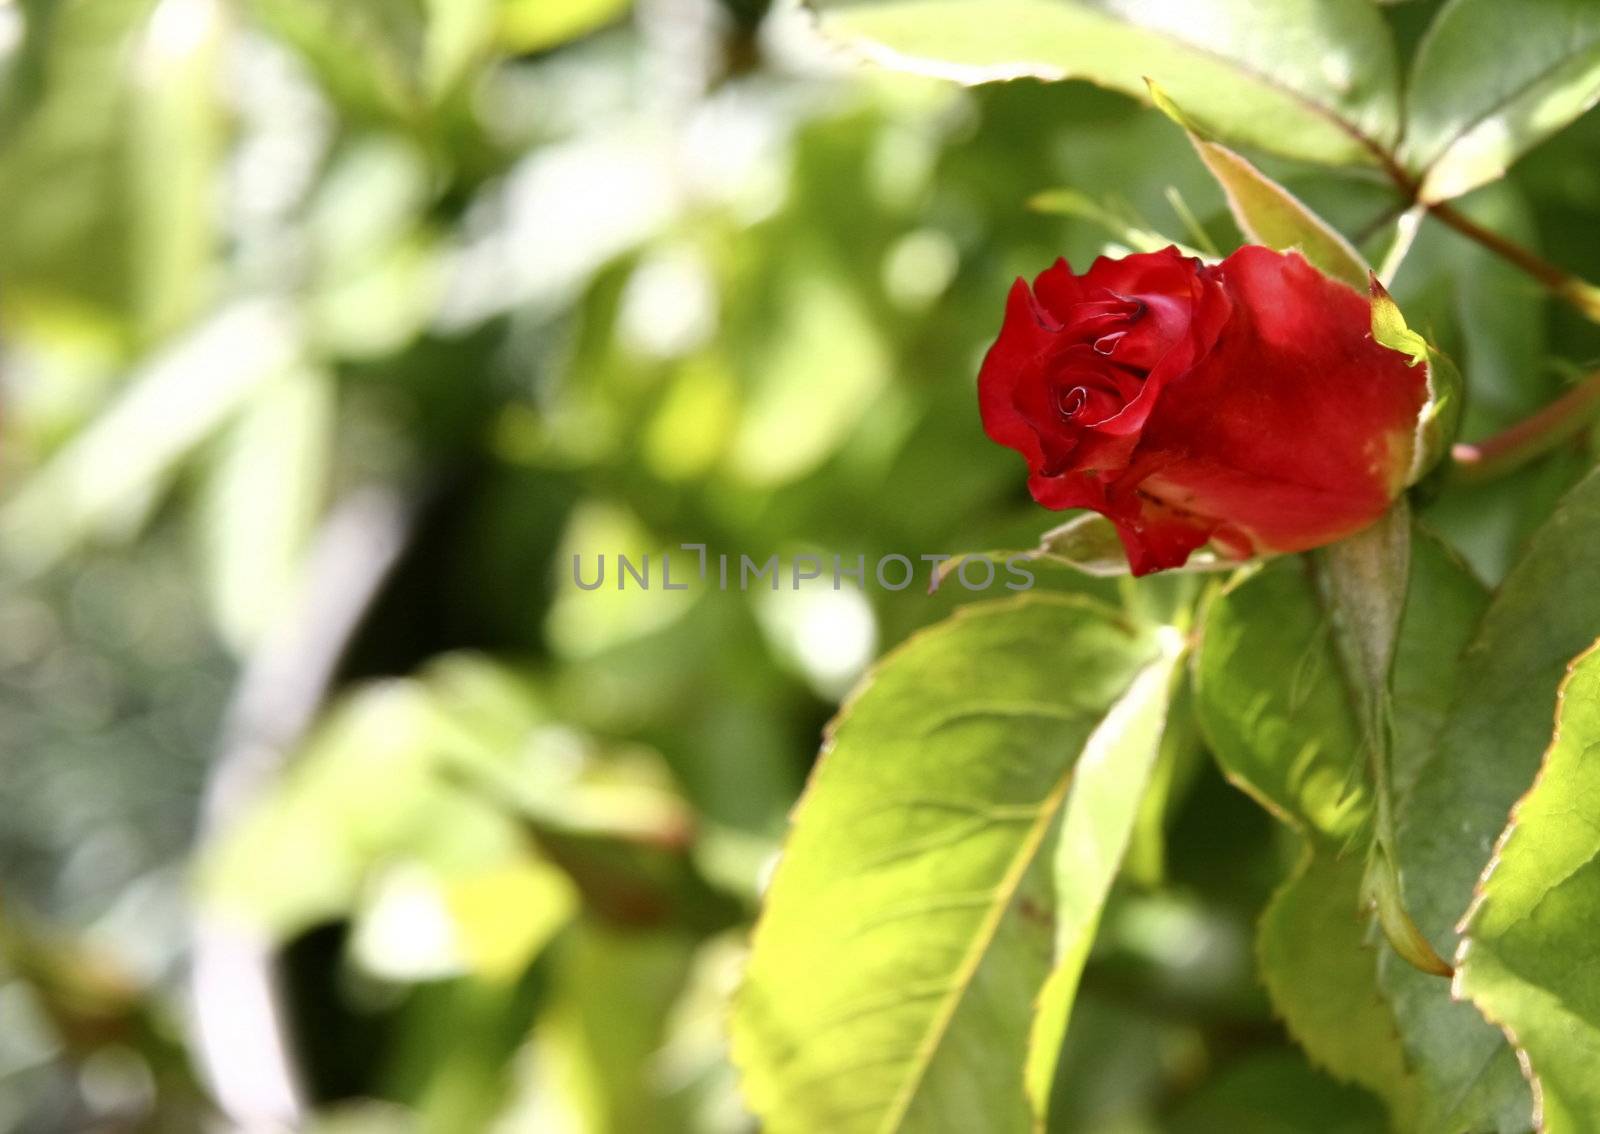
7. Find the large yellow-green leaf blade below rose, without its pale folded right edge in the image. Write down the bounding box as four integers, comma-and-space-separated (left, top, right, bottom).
733, 595, 1171, 1134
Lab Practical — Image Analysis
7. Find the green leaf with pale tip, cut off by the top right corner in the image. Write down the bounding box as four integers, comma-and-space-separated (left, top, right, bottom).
1402, 0, 1600, 202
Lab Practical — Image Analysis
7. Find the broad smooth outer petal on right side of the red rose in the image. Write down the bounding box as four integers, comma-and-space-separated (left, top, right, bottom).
1139, 246, 1427, 552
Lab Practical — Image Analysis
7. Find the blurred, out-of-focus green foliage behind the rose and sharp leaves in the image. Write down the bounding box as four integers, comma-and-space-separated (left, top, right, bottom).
0, 0, 1600, 1132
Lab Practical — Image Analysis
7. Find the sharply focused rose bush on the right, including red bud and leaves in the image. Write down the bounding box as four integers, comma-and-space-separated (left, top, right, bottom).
730, 0, 1600, 1134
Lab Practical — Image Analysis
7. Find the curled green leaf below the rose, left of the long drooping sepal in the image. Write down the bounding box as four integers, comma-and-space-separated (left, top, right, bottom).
1195, 560, 1403, 1113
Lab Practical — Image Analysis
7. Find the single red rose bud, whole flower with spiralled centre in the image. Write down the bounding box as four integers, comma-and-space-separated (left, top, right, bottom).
978, 246, 1429, 574
